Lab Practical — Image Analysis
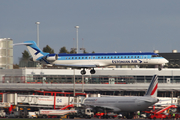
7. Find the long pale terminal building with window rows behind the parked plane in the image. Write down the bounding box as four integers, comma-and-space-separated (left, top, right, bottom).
0, 68, 180, 97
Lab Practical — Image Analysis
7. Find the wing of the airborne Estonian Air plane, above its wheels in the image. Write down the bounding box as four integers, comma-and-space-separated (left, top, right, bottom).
53, 64, 97, 68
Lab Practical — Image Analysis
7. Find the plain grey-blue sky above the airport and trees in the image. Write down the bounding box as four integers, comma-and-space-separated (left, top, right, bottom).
0, 0, 180, 63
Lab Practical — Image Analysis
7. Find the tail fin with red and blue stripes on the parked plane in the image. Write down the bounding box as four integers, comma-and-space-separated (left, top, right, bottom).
145, 75, 158, 97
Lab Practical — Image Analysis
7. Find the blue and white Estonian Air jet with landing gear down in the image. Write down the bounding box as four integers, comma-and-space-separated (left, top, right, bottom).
14, 41, 168, 75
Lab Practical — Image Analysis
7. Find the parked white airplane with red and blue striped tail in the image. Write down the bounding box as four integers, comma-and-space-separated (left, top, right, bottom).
82, 75, 159, 118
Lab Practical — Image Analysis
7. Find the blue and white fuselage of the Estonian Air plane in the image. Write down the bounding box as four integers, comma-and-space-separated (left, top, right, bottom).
49, 53, 168, 67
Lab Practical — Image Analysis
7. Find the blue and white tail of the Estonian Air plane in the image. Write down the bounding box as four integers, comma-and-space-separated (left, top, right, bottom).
14, 41, 49, 61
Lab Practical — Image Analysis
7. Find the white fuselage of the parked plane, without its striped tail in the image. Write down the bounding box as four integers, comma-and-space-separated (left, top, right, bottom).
84, 96, 158, 112
